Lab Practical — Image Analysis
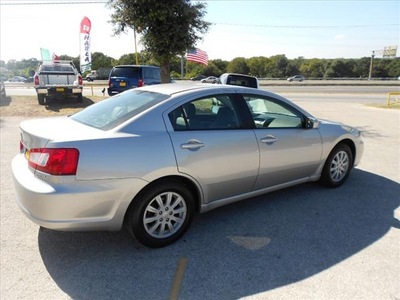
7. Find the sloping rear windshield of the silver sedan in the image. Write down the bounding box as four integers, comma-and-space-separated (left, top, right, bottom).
71, 90, 169, 130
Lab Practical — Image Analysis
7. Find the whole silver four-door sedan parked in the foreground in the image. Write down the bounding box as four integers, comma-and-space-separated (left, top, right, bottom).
12, 84, 363, 247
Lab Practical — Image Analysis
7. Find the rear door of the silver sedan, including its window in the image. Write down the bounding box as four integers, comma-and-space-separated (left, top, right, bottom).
169, 95, 259, 203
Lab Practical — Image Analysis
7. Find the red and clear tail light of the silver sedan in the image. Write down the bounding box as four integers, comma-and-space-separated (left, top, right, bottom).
29, 148, 79, 175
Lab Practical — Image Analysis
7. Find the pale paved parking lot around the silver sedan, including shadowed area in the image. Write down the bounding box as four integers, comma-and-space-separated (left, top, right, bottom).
0, 89, 400, 300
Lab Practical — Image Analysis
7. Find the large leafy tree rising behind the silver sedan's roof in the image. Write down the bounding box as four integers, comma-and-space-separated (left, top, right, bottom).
108, 0, 211, 82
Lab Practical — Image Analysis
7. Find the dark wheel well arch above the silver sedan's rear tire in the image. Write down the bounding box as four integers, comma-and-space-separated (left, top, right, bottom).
124, 176, 201, 223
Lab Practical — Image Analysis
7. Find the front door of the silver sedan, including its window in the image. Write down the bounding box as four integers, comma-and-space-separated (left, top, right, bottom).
245, 96, 322, 189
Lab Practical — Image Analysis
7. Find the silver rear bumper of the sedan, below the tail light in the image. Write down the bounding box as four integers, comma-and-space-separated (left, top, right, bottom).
12, 155, 146, 231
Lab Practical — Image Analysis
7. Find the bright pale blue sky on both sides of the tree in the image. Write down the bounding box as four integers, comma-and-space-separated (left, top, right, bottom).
0, 0, 400, 62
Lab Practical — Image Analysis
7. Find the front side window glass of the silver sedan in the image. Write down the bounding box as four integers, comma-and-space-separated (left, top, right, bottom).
245, 96, 304, 128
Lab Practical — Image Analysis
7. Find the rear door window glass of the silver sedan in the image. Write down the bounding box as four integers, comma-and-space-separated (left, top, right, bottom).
169, 95, 241, 131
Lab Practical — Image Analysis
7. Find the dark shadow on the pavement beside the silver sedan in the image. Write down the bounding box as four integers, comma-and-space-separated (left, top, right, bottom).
38, 169, 400, 299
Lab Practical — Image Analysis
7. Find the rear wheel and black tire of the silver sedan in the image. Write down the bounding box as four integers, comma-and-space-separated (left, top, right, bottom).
125, 181, 195, 248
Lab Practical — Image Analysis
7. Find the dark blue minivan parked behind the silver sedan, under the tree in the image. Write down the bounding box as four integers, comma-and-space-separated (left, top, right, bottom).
108, 65, 161, 96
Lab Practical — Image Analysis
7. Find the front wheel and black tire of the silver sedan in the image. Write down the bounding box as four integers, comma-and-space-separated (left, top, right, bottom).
320, 144, 353, 188
